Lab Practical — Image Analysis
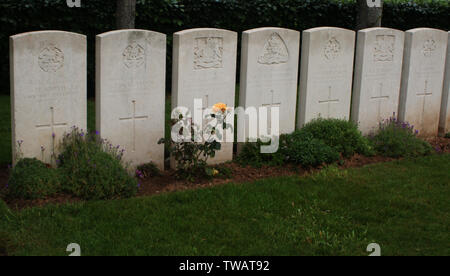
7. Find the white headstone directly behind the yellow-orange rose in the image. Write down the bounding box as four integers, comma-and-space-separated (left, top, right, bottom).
172, 28, 237, 163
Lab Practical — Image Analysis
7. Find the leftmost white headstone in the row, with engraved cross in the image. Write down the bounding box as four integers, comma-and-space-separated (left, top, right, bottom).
10, 31, 87, 165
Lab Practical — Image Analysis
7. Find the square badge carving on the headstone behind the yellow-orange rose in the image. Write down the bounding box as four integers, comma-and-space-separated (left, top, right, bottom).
194, 37, 223, 70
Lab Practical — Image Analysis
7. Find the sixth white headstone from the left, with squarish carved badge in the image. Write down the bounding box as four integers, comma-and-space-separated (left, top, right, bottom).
351, 28, 404, 135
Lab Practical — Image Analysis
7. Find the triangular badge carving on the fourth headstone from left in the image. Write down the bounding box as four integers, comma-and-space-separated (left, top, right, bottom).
258, 33, 289, 65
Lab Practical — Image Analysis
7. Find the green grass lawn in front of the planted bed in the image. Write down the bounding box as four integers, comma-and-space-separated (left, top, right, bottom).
0, 155, 450, 255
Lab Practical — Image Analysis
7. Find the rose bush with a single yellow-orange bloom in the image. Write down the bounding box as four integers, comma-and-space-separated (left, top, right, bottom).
159, 103, 232, 181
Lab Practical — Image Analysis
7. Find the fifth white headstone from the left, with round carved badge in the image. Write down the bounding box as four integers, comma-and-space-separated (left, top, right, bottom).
297, 27, 355, 128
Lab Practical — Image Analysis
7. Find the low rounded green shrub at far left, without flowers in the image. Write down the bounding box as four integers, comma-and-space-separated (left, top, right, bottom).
7, 158, 61, 199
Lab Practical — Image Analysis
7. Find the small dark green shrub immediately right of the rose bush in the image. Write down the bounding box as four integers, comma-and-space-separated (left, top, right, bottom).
236, 138, 287, 168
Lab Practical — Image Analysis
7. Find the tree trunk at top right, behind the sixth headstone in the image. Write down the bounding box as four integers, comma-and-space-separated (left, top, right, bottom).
356, 0, 383, 31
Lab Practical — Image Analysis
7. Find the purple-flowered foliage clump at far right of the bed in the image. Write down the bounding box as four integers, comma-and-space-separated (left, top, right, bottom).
369, 117, 433, 158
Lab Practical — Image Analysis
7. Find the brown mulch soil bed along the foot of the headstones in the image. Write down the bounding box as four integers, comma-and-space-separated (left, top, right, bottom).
0, 137, 450, 210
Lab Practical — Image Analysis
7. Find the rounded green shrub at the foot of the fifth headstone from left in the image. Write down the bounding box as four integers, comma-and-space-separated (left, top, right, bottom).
302, 118, 373, 157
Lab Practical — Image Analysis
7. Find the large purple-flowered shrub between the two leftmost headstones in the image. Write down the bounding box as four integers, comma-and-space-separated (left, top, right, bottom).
57, 127, 138, 199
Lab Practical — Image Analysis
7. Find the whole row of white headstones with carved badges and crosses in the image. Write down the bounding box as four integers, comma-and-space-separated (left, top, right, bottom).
10, 27, 450, 167
